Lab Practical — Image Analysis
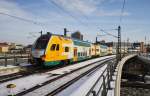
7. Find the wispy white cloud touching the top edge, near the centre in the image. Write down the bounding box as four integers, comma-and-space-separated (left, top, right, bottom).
53, 0, 104, 15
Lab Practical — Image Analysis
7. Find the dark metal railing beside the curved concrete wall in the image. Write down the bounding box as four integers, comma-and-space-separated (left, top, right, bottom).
86, 59, 115, 96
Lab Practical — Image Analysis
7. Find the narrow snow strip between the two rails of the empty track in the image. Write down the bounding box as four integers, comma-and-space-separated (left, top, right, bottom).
24, 60, 111, 96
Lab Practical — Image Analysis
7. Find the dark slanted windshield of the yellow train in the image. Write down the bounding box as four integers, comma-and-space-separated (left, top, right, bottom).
34, 35, 51, 49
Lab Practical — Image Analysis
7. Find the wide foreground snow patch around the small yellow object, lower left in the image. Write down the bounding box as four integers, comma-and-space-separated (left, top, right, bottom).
0, 74, 56, 96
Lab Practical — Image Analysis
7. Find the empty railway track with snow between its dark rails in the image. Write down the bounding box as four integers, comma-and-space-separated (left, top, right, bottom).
16, 58, 112, 96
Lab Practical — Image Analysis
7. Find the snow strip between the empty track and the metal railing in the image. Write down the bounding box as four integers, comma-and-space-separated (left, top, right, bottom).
57, 65, 107, 96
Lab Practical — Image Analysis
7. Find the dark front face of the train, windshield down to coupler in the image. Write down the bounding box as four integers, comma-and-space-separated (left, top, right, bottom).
32, 34, 51, 66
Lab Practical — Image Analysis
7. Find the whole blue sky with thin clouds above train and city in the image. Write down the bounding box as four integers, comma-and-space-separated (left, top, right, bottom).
0, 0, 150, 44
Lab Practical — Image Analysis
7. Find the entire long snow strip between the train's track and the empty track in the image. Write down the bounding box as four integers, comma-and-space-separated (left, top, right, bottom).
0, 55, 114, 96
